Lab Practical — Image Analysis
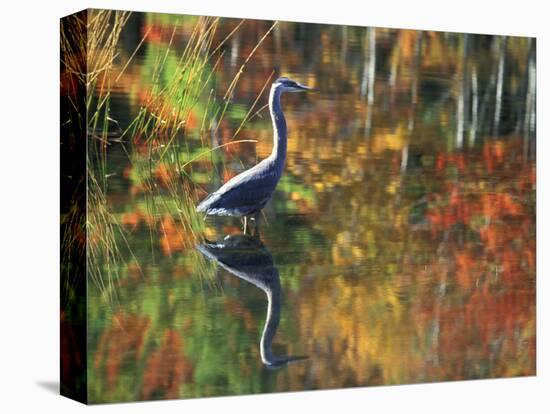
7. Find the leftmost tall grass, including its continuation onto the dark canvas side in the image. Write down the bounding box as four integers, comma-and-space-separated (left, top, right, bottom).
60, 10, 130, 300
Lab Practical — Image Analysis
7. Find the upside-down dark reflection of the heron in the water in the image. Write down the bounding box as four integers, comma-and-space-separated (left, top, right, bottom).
197, 235, 307, 367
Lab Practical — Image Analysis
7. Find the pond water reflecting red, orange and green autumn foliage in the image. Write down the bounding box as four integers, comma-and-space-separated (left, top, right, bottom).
88, 14, 536, 402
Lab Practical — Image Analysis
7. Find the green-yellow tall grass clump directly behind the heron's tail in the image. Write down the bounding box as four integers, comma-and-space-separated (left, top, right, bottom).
125, 17, 224, 252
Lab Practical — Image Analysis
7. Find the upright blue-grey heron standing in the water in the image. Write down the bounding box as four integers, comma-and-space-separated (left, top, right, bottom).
197, 78, 313, 234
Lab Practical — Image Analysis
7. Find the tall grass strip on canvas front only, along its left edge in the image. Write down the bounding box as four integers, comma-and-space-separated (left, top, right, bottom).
86, 10, 130, 302
